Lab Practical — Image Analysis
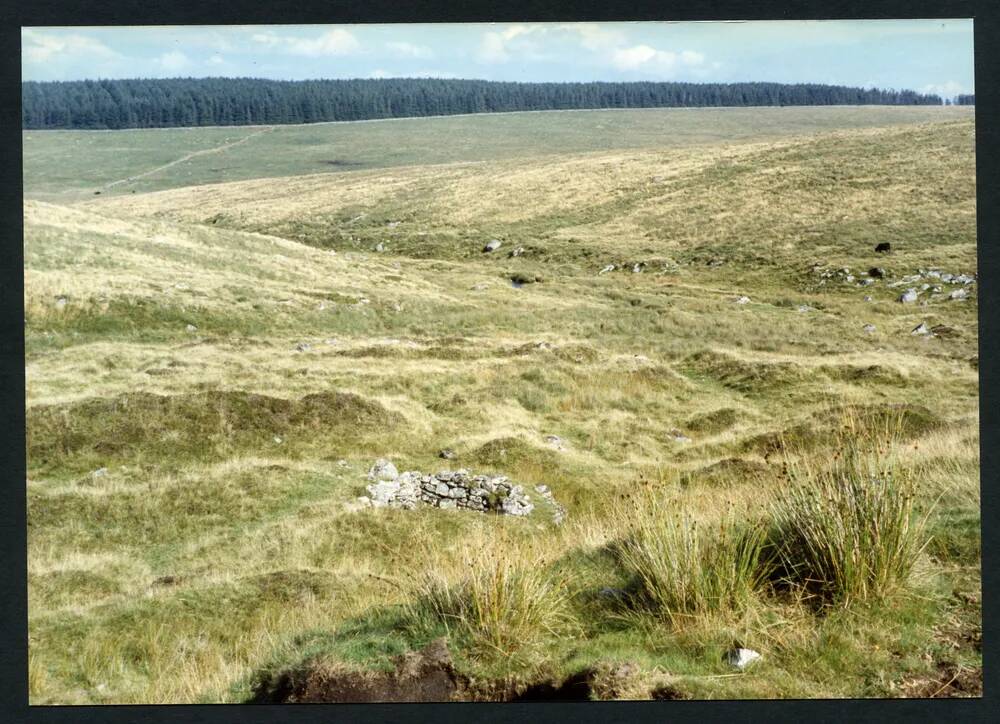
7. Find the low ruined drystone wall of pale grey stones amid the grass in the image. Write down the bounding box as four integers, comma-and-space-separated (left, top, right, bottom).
358, 458, 566, 523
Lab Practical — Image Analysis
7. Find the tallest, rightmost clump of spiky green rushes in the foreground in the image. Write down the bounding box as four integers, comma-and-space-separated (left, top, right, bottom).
771, 444, 927, 606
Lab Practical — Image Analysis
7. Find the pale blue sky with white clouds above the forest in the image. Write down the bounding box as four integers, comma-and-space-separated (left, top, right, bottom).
21, 19, 974, 97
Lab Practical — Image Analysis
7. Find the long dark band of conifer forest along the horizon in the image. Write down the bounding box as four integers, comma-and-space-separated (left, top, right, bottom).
21, 78, 942, 129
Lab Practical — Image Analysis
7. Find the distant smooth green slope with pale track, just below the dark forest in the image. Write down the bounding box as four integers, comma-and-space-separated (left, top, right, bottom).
22, 106, 971, 202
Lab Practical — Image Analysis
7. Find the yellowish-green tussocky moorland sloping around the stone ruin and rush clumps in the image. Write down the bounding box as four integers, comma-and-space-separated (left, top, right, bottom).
25, 109, 981, 703
